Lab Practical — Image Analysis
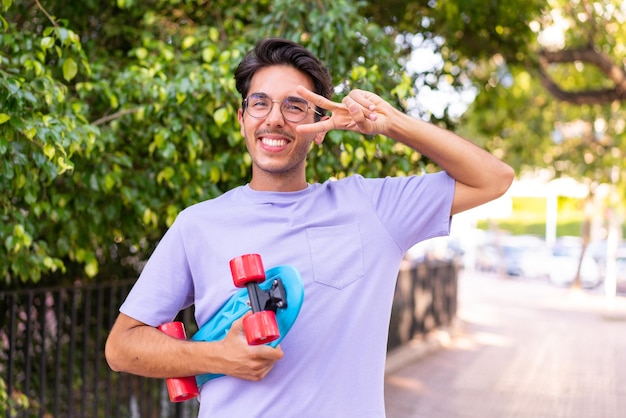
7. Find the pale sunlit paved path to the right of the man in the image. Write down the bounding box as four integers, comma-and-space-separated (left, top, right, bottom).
385, 273, 626, 418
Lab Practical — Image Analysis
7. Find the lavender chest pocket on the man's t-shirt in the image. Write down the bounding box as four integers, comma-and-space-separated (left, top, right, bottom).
307, 224, 363, 289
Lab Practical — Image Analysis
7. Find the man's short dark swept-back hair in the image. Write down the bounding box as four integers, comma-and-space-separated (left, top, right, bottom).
235, 38, 333, 118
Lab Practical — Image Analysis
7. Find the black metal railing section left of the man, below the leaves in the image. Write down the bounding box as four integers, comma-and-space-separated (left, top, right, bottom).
0, 280, 196, 418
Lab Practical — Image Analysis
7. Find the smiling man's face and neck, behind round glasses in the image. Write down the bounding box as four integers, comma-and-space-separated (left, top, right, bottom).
238, 66, 323, 187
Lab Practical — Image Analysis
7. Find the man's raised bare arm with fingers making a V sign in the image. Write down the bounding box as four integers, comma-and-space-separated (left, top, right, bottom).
297, 87, 515, 215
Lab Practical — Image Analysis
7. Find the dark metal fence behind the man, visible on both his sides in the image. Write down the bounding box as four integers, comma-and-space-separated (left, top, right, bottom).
0, 262, 457, 418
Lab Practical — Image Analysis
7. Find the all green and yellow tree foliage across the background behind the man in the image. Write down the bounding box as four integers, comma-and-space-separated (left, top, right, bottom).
7, 0, 626, 285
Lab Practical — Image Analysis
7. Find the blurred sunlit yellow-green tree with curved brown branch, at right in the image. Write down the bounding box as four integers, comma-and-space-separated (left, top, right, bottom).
458, 0, 626, 285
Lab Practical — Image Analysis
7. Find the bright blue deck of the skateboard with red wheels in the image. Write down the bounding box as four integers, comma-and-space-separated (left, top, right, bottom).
191, 265, 304, 386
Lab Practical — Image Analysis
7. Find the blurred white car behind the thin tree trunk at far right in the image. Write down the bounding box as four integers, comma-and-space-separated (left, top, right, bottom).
548, 237, 602, 289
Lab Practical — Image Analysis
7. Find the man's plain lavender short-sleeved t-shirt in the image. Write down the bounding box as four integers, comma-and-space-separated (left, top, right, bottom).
120, 172, 454, 418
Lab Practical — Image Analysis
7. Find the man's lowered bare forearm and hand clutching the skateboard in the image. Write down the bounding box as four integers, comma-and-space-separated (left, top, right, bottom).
105, 314, 283, 380
